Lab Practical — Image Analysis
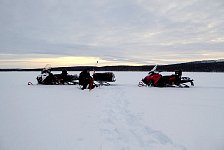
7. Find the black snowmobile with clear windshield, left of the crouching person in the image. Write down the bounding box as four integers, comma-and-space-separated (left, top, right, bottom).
36, 67, 78, 85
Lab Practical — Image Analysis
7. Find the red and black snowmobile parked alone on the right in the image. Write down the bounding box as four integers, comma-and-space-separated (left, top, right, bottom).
138, 66, 194, 87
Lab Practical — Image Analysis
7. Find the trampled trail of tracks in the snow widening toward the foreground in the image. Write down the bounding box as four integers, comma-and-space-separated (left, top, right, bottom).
100, 87, 186, 150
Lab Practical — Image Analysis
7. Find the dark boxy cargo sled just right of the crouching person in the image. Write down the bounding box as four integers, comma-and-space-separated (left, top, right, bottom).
93, 72, 116, 86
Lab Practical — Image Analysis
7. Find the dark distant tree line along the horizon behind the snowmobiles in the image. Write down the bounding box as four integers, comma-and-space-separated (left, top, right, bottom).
0, 61, 224, 72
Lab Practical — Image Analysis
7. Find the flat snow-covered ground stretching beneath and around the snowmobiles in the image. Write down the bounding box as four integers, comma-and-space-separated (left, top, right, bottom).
0, 72, 224, 150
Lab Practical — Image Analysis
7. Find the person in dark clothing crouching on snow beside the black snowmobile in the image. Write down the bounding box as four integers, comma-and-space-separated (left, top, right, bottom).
79, 69, 94, 90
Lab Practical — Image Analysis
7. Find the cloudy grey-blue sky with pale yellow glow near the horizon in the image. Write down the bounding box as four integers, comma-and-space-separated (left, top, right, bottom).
0, 0, 224, 68
